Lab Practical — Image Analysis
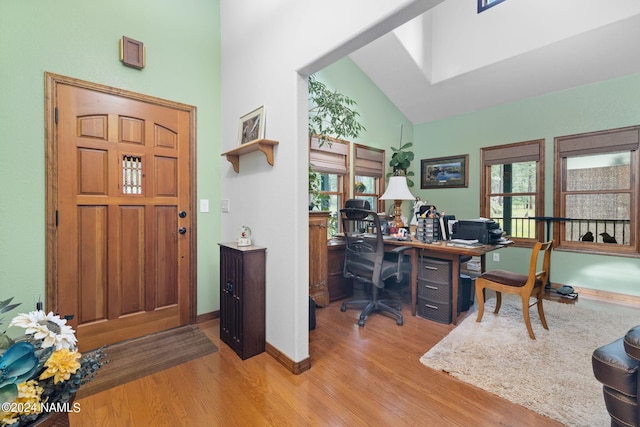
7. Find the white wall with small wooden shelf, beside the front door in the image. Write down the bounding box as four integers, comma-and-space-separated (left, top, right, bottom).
220, 0, 442, 362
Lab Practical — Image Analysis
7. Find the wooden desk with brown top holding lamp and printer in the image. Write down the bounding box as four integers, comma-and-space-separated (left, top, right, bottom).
384, 239, 507, 325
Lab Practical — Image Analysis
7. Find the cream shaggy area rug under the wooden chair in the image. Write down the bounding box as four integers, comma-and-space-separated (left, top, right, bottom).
420, 295, 640, 427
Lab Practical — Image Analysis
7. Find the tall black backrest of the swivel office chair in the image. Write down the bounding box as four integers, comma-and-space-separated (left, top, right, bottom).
340, 199, 384, 288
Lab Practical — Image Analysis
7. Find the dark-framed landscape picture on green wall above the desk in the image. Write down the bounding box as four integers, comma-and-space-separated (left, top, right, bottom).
420, 154, 469, 188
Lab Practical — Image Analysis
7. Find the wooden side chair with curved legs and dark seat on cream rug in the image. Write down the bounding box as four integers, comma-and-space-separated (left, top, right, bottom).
476, 241, 552, 340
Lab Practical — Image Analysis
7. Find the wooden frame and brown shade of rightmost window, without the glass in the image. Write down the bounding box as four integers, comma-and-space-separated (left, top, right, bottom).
553, 126, 640, 257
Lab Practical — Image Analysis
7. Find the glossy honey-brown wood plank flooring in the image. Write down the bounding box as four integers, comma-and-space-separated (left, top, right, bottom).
70, 294, 591, 427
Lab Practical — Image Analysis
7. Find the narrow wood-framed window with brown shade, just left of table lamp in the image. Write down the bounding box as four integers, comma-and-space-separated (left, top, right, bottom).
353, 144, 385, 212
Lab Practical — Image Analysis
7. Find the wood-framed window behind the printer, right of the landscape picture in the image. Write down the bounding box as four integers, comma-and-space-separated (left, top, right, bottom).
480, 139, 545, 246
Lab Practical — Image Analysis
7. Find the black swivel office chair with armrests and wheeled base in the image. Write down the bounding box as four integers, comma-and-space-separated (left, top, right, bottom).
340, 199, 411, 326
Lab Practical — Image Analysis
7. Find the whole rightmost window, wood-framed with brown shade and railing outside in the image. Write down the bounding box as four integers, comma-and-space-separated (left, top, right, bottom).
554, 127, 640, 255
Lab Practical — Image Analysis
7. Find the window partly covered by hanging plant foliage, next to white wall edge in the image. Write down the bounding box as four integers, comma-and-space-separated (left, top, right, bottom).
309, 137, 349, 237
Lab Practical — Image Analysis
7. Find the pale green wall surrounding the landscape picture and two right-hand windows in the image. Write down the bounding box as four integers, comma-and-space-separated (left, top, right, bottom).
414, 74, 640, 295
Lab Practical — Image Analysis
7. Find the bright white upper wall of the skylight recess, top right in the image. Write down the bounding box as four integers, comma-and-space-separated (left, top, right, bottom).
424, 0, 640, 83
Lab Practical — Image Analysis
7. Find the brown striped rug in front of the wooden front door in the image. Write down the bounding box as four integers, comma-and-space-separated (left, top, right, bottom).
77, 325, 218, 399
